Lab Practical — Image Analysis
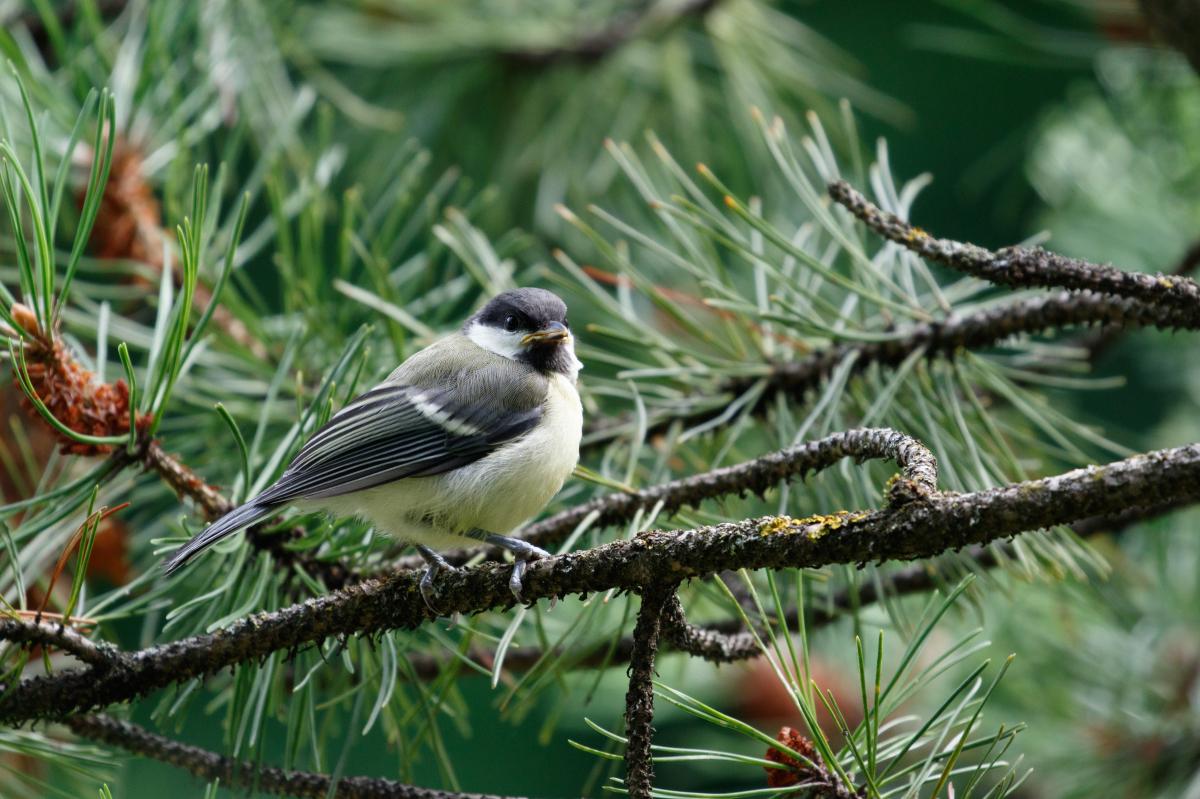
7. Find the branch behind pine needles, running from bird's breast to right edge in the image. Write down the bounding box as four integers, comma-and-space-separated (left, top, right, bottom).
584, 286, 1200, 450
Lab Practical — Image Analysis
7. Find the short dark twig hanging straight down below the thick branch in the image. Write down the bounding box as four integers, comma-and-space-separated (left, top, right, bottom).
625, 583, 677, 799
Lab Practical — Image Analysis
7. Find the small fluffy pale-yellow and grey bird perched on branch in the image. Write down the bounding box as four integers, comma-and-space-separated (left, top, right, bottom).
164, 288, 583, 612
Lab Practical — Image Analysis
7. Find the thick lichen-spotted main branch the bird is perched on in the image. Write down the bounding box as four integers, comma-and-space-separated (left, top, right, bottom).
0, 436, 1200, 723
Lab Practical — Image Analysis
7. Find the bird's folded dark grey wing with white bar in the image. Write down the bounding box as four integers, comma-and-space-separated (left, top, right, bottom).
256, 383, 541, 504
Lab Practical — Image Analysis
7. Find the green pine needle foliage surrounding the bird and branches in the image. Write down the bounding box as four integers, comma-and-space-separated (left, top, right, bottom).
0, 0, 1196, 799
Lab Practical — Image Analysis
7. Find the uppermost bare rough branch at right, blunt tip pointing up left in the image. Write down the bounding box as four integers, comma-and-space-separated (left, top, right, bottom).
829, 180, 1200, 311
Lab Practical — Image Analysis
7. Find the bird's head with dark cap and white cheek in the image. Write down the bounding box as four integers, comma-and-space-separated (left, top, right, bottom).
463, 288, 582, 379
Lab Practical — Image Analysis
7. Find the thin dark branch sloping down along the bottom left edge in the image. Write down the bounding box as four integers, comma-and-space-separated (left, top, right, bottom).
66, 715, 518, 799
